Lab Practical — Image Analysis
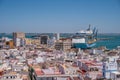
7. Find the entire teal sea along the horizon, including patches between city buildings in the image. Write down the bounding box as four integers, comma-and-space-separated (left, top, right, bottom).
0, 33, 120, 50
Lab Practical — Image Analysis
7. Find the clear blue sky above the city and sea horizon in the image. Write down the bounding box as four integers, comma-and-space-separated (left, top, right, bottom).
0, 0, 120, 33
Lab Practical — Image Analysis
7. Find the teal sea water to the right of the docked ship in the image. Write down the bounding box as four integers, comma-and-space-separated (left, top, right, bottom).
95, 33, 120, 49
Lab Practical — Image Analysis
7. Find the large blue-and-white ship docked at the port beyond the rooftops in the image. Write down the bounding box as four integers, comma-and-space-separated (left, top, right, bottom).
72, 25, 98, 49
